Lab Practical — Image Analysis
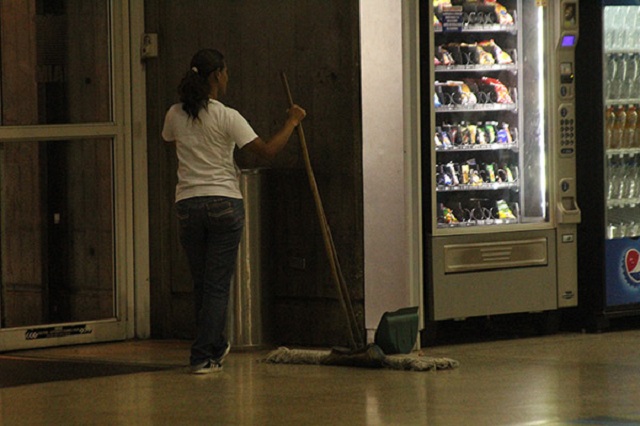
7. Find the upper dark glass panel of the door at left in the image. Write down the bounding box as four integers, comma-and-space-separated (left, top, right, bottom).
0, 0, 112, 126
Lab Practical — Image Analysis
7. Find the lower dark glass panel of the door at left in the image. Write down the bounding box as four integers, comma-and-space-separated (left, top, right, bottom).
0, 139, 116, 328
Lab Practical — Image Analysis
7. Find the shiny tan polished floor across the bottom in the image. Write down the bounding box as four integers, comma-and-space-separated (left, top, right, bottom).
0, 329, 640, 426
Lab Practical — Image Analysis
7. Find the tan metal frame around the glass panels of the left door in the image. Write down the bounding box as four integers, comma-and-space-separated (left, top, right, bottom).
0, 0, 150, 352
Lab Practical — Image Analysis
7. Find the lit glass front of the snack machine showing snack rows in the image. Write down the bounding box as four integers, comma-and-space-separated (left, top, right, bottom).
431, 0, 549, 235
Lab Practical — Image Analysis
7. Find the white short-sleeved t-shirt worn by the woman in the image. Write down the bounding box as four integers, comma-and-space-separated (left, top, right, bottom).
162, 99, 258, 202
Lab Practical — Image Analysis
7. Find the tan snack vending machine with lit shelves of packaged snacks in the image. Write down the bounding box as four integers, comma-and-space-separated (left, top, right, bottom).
420, 0, 581, 334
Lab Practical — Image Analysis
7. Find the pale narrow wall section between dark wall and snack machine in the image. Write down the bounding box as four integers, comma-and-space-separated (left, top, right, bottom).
360, 0, 422, 341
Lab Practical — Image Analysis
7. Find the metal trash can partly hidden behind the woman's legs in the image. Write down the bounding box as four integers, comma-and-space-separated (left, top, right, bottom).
226, 169, 270, 348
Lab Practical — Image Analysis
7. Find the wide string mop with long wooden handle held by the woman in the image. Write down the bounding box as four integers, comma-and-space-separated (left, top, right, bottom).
264, 72, 458, 371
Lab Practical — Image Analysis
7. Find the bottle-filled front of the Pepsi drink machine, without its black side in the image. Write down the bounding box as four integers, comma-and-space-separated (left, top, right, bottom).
602, 1, 640, 310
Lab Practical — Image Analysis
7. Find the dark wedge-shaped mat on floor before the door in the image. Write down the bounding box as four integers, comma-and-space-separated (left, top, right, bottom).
0, 356, 166, 388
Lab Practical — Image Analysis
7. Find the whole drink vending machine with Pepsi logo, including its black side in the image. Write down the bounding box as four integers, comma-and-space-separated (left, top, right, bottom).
576, 0, 640, 331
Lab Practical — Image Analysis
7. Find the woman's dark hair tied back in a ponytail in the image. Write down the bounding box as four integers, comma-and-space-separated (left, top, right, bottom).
178, 49, 225, 120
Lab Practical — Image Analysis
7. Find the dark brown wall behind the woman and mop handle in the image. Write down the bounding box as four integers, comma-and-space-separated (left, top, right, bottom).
145, 0, 364, 345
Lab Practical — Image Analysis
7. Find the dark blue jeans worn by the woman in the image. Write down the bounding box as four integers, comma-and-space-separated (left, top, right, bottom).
176, 197, 244, 365
